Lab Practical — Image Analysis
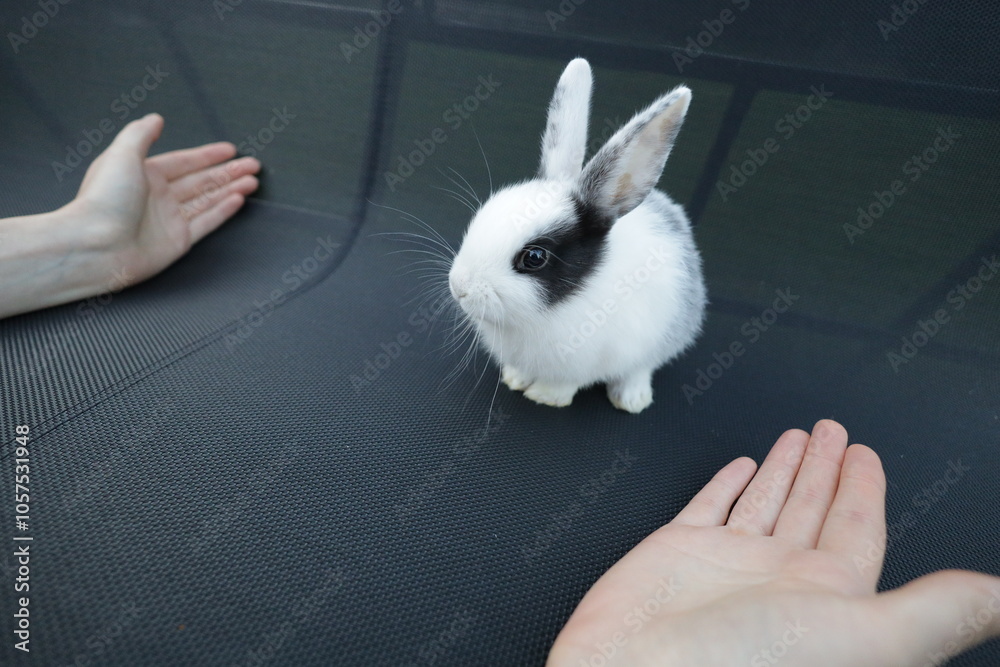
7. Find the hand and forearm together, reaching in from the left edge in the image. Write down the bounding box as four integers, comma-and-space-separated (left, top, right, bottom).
0, 114, 260, 318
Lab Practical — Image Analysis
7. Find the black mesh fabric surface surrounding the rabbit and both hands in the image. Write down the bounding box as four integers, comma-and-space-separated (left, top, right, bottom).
0, 0, 1000, 667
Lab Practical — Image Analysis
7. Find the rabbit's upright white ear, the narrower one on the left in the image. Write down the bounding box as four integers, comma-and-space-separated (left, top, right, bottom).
538, 58, 593, 180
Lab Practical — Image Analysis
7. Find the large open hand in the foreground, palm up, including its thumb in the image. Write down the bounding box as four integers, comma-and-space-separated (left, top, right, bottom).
547, 420, 1000, 667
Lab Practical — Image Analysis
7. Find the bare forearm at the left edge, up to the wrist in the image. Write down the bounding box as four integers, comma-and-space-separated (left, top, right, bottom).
0, 202, 122, 319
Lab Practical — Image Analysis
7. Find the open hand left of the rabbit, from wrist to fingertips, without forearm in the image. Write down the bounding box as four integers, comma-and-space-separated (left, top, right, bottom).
73, 114, 260, 283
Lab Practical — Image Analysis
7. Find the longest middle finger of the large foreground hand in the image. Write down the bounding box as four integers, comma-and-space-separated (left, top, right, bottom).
772, 419, 847, 549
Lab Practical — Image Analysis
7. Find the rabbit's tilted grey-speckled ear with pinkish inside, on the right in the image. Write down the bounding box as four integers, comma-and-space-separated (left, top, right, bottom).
577, 86, 691, 223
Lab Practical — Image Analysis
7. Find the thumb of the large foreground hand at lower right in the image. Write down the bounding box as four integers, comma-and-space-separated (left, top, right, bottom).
877, 570, 1000, 667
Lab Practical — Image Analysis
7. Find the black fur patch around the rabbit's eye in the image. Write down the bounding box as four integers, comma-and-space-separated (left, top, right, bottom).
511, 200, 613, 305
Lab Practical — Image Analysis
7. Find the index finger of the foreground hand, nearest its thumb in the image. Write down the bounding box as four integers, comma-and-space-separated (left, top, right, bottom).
817, 445, 886, 592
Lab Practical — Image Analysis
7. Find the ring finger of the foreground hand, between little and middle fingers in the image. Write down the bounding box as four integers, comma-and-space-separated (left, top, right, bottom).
726, 429, 809, 535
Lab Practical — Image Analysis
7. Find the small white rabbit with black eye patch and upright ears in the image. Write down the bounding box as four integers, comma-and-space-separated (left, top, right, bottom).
448, 58, 707, 413
